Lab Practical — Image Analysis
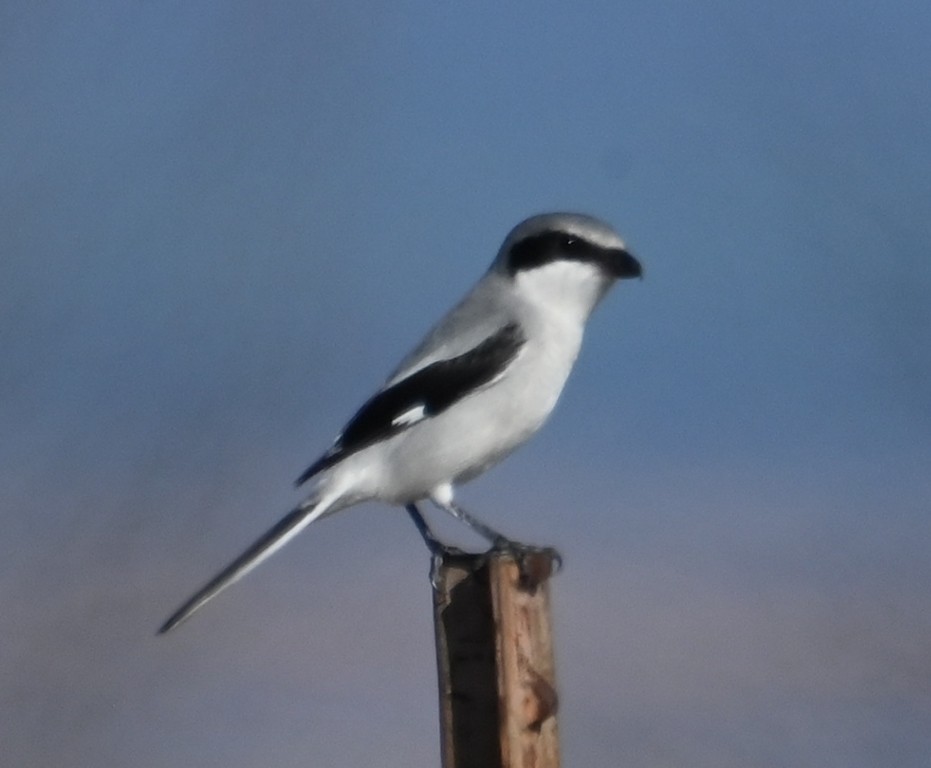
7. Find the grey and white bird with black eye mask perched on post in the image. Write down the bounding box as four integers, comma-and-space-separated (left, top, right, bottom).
158, 213, 643, 634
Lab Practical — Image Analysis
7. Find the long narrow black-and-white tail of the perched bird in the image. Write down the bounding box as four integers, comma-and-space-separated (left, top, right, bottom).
158, 499, 333, 635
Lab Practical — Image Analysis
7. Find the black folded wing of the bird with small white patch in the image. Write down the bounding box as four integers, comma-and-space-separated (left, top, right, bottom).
296, 323, 526, 485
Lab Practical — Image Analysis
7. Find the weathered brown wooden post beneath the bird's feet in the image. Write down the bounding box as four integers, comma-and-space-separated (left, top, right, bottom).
433, 551, 559, 768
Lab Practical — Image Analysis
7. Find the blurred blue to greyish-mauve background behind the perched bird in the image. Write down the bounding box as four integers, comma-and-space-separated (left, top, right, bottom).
0, 0, 931, 768
